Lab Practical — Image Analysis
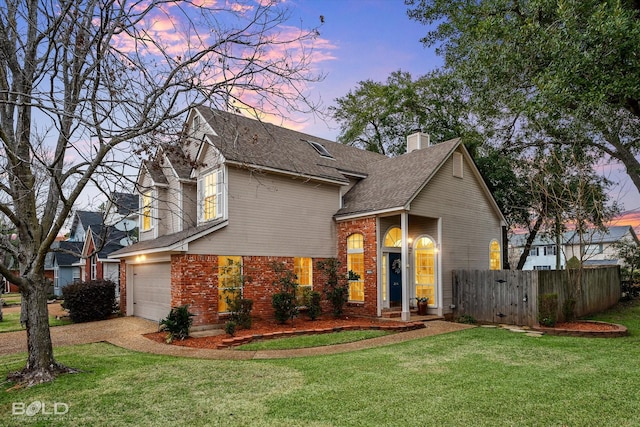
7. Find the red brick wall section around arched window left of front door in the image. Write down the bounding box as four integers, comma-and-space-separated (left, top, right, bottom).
336, 217, 378, 317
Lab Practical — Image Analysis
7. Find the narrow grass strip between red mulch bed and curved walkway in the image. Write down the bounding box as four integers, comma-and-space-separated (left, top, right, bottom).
236, 330, 389, 351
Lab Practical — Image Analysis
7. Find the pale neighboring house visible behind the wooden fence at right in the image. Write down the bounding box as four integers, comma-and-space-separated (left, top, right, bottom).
509, 225, 640, 270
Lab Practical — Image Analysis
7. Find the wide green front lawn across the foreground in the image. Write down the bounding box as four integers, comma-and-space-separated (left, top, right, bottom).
0, 304, 640, 426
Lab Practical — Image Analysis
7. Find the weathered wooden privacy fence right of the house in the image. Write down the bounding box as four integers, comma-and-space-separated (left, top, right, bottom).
453, 267, 620, 326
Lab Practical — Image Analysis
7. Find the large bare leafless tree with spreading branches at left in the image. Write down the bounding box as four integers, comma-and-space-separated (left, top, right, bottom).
0, 0, 322, 384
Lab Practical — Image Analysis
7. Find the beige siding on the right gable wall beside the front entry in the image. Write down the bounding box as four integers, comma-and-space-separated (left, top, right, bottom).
410, 149, 503, 312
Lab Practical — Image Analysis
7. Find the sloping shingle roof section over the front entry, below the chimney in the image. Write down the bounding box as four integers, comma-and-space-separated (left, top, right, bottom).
337, 138, 460, 215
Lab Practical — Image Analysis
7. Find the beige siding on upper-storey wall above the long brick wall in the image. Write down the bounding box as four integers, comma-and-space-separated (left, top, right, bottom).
189, 167, 339, 258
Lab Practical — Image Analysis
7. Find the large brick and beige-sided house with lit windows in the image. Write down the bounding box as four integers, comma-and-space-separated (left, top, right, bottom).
110, 107, 505, 325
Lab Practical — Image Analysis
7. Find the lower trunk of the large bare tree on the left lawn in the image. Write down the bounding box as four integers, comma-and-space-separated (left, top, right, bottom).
7, 275, 77, 387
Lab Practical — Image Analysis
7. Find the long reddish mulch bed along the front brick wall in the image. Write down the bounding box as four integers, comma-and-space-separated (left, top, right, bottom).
144, 317, 416, 349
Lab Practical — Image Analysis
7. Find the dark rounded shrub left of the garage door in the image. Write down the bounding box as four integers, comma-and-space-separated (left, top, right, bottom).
62, 280, 116, 323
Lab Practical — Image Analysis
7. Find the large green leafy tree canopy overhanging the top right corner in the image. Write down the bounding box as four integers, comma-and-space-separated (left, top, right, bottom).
405, 0, 640, 195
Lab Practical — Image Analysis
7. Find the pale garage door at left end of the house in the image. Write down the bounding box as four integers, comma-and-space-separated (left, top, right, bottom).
131, 262, 171, 322
